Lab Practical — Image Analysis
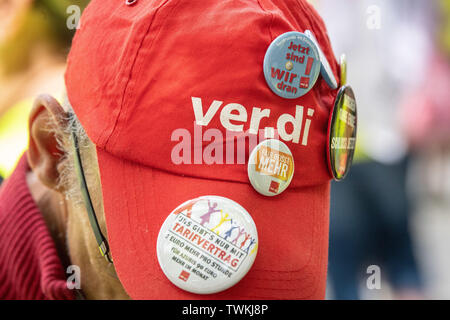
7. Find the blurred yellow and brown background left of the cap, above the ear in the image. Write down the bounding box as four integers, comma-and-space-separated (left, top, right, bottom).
0, 0, 89, 177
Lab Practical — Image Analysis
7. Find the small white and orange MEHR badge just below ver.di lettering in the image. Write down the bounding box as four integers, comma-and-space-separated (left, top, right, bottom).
247, 139, 294, 196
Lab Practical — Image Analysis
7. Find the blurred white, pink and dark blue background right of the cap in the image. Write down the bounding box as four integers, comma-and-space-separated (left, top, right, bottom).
315, 0, 450, 299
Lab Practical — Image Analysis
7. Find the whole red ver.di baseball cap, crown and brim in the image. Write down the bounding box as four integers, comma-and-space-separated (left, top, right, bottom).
65, 0, 339, 299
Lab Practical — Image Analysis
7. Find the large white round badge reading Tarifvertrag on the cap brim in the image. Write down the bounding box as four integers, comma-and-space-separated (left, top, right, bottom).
157, 196, 258, 294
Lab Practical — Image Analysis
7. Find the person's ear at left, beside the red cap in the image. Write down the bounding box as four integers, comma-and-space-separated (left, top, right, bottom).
27, 95, 66, 191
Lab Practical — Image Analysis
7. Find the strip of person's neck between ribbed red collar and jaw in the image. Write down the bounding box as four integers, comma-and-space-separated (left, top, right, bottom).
26, 171, 70, 268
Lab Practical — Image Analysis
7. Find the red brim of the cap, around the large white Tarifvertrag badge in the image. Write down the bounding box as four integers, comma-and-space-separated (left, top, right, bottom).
97, 149, 329, 300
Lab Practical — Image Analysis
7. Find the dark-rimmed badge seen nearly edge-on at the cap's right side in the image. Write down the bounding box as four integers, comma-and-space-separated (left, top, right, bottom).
328, 85, 357, 180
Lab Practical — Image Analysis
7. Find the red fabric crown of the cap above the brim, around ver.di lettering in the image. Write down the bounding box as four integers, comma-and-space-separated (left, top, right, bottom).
65, 0, 338, 187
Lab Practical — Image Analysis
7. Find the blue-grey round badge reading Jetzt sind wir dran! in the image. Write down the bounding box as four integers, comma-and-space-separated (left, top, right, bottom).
264, 31, 320, 99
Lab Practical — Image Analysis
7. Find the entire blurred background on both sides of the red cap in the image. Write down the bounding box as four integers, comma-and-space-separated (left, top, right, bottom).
0, 0, 450, 299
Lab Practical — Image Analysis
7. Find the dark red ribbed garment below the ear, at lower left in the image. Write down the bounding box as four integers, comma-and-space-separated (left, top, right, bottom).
0, 156, 74, 300
